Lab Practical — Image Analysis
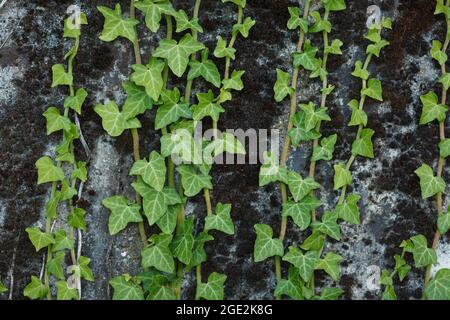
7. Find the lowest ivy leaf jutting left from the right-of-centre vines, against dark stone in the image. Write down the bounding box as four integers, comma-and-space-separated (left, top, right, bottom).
253, 224, 284, 262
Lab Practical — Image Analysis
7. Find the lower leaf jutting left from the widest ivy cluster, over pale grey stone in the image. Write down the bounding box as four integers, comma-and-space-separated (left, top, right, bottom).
102, 196, 142, 235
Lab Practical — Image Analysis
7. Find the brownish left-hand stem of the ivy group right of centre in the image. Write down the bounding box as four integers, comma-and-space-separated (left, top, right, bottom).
275, 0, 311, 290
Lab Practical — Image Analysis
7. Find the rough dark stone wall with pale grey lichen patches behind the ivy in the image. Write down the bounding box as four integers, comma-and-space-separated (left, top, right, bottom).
0, 0, 450, 299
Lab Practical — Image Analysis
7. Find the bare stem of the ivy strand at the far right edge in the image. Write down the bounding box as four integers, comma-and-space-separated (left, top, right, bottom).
425, 13, 450, 288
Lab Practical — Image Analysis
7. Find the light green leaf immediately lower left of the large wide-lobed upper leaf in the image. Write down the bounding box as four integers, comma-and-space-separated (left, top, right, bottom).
130, 57, 165, 101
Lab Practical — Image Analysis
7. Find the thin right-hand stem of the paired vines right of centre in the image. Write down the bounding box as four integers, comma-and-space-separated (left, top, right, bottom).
309, 9, 330, 294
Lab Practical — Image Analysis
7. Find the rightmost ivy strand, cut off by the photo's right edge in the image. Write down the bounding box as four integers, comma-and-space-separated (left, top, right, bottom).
381, 0, 450, 300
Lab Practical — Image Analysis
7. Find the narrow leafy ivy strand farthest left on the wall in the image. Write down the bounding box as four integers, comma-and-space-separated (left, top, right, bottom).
24, 13, 94, 300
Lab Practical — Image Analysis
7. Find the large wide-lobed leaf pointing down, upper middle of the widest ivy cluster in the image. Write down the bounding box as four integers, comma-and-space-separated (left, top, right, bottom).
153, 33, 205, 77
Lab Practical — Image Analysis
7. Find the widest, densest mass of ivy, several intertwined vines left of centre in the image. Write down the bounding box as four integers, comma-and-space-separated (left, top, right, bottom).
95, 0, 254, 299
